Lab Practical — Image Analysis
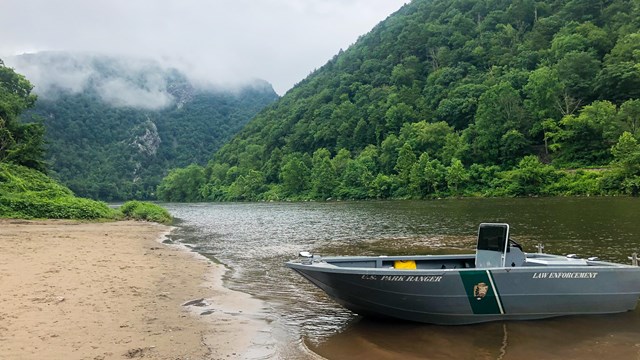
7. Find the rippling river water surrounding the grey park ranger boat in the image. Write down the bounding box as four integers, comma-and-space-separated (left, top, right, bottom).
164, 198, 640, 359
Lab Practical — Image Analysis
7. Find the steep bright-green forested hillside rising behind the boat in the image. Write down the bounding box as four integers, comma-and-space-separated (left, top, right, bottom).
159, 0, 640, 201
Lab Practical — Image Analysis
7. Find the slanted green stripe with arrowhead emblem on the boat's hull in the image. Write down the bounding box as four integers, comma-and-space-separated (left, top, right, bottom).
460, 270, 504, 314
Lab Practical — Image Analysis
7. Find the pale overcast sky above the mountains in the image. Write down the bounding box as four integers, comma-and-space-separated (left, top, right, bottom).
0, 0, 409, 95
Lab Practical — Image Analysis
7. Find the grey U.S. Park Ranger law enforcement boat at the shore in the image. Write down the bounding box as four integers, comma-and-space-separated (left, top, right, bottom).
286, 223, 640, 325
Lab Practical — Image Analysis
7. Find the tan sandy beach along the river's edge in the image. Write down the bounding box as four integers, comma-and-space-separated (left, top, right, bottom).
0, 220, 273, 360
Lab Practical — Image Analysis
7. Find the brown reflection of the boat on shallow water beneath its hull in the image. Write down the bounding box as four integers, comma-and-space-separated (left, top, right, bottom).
311, 312, 640, 360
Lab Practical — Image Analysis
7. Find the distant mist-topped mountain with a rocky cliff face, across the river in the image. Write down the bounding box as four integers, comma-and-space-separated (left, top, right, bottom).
6, 52, 278, 200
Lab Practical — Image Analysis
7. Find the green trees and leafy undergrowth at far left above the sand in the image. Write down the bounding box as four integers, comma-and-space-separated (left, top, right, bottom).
0, 60, 116, 219
